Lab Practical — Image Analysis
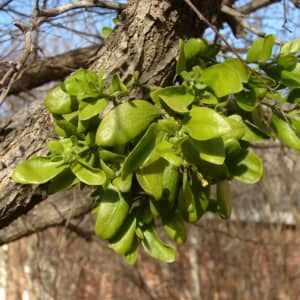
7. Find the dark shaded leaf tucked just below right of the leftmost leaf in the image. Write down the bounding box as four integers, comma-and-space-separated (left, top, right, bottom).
48, 168, 79, 195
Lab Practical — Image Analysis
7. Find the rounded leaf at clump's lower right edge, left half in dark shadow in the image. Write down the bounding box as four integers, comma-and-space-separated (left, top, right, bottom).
228, 150, 263, 184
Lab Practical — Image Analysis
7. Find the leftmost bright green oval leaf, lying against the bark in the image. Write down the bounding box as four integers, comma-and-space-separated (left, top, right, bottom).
12, 156, 66, 184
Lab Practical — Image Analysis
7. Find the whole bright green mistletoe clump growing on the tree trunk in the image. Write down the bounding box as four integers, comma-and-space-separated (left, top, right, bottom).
13, 35, 300, 264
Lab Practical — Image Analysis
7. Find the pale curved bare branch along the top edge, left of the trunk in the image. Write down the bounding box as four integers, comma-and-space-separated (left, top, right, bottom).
38, 0, 126, 17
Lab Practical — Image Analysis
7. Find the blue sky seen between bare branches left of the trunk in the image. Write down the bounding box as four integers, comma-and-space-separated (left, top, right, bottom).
0, 0, 126, 59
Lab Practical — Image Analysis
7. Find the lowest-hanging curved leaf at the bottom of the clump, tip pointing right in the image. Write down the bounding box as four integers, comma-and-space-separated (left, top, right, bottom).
142, 225, 176, 263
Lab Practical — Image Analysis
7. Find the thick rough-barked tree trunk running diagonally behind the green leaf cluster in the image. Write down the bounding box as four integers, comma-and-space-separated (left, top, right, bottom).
0, 0, 225, 244
